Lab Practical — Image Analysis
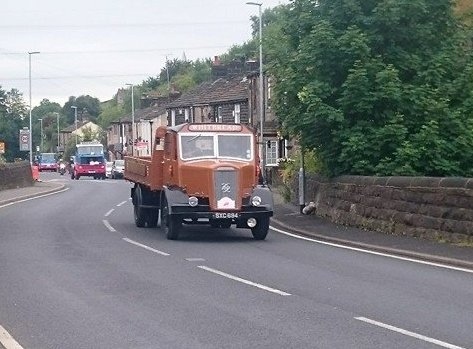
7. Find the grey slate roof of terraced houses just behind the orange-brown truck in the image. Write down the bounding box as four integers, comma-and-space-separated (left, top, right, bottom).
166, 76, 249, 108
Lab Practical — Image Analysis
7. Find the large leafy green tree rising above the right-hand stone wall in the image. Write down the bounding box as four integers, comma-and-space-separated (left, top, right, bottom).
267, 0, 473, 176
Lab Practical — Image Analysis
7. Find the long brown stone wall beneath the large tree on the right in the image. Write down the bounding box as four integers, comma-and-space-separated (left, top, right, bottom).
295, 176, 473, 243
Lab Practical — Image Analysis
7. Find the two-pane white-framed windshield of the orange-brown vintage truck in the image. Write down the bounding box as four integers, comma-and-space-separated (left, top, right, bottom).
180, 134, 252, 161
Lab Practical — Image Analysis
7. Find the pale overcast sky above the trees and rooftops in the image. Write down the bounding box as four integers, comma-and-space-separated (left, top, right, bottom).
0, 0, 289, 106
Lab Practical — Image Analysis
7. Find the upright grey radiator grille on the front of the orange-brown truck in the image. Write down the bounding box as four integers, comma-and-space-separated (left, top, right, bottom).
214, 168, 238, 210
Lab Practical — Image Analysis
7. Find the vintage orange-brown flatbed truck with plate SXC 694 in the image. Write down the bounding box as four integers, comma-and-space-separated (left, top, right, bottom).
124, 123, 273, 240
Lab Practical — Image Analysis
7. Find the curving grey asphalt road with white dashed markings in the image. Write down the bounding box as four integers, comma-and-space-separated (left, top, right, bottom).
0, 173, 473, 349
